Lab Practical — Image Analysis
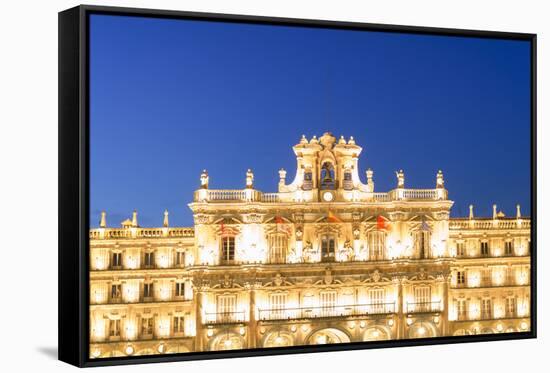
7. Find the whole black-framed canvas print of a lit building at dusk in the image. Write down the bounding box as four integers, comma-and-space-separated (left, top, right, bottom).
59, 6, 536, 366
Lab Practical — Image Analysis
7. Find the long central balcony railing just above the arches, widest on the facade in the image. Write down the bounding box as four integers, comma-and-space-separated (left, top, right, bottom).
258, 303, 395, 321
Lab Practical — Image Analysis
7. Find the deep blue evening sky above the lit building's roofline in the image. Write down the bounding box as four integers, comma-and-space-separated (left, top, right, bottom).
90, 15, 530, 227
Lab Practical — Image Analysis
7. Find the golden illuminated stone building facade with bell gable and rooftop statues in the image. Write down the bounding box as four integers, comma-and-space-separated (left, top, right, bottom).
90, 133, 530, 358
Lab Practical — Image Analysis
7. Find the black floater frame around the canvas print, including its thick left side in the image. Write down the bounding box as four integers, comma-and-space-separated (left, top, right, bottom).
58, 5, 537, 367
